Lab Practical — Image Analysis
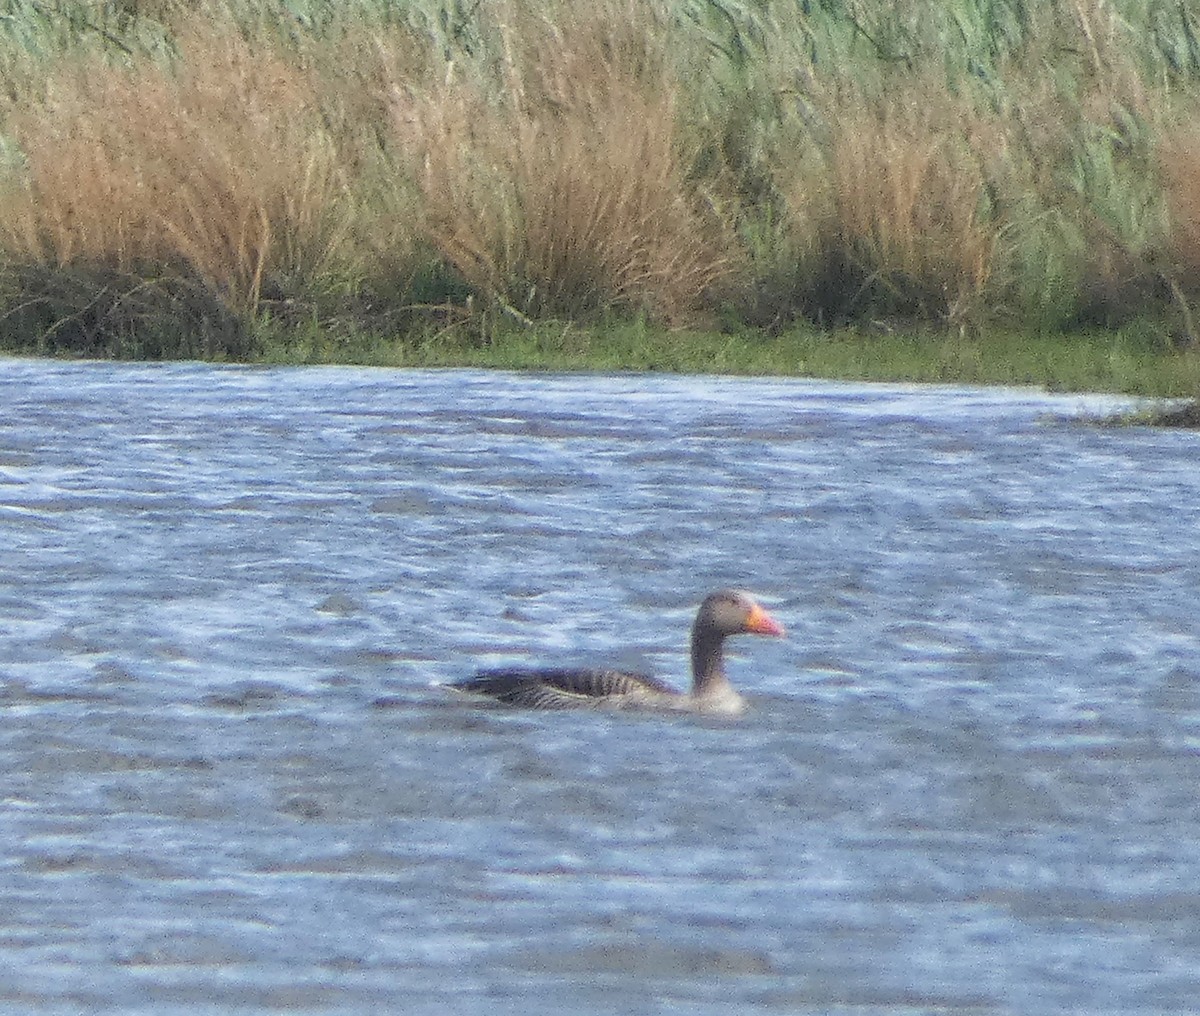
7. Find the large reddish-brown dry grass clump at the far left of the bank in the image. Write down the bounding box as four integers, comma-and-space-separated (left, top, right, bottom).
0, 22, 347, 345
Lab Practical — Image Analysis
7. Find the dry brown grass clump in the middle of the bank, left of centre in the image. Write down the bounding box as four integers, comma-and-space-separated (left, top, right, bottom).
394, 8, 728, 321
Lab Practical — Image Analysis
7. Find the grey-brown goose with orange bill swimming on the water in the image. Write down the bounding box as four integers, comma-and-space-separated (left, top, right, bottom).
450, 589, 784, 714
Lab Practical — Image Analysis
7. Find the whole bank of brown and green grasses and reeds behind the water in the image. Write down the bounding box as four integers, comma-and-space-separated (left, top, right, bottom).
0, 0, 1200, 410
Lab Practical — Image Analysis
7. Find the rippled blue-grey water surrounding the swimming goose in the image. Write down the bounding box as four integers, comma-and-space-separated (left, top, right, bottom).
0, 361, 1200, 1016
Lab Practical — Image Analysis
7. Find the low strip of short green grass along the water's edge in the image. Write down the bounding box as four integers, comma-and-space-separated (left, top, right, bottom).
241, 321, 1200, 398
